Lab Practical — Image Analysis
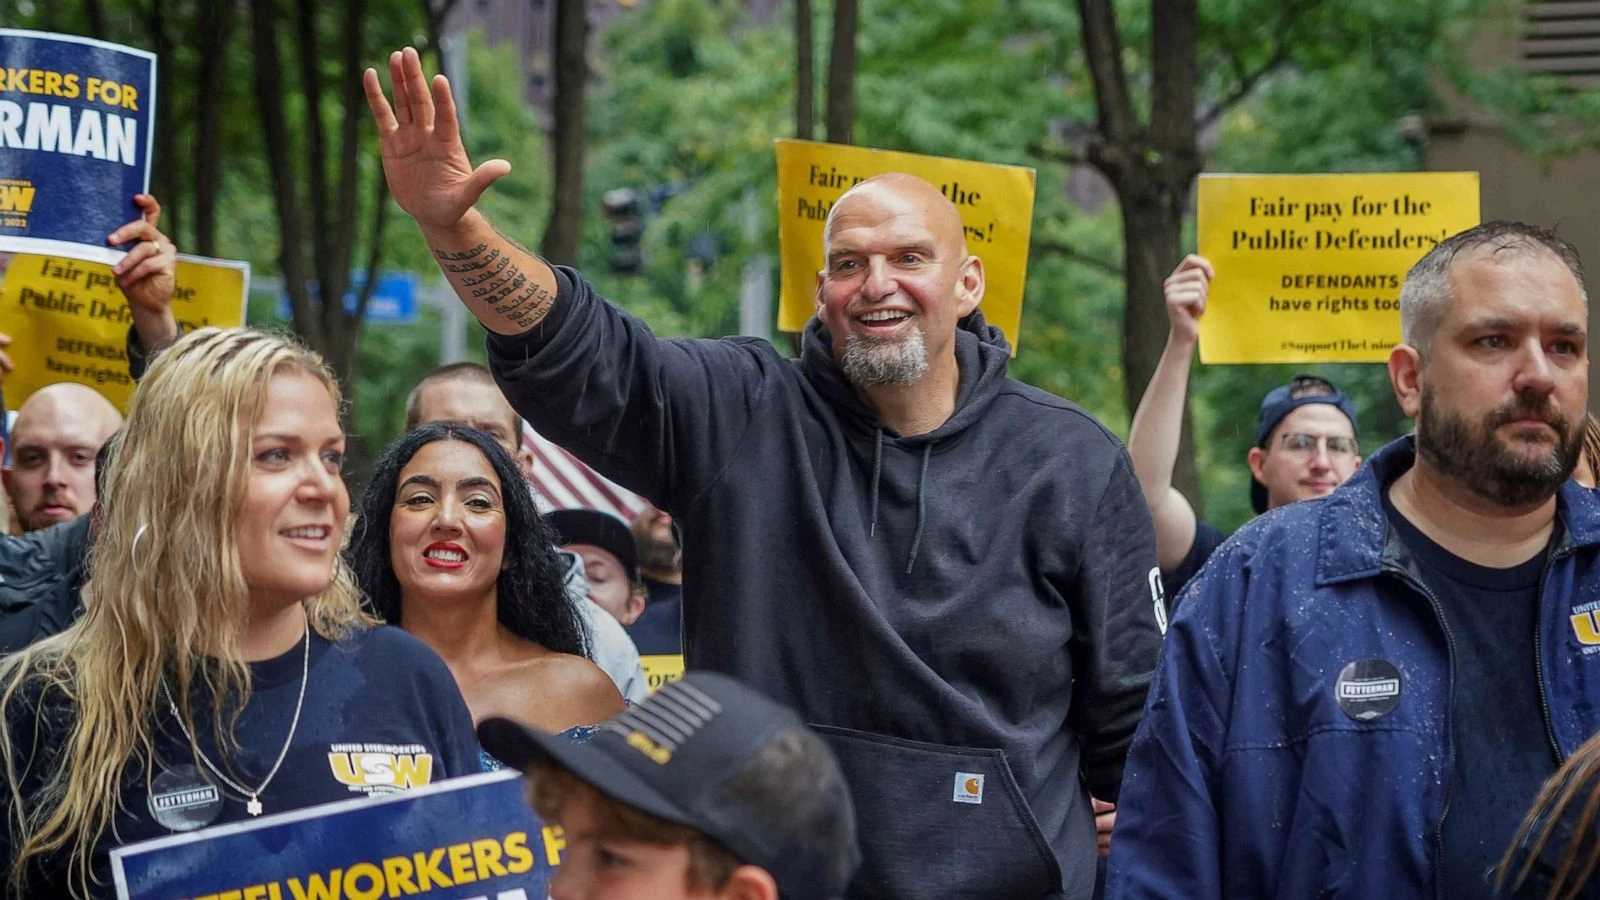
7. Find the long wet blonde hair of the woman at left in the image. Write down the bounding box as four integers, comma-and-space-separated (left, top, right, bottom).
0, 328, 370, 894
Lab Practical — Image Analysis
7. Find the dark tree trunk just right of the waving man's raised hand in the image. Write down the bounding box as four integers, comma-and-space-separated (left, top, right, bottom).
539, 0, 589, 266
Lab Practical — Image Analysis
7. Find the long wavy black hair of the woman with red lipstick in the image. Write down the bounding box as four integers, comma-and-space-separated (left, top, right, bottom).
349, 423, 587, 657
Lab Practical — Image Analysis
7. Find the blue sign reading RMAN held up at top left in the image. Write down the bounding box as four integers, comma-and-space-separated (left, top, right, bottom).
0, 29, 155, 263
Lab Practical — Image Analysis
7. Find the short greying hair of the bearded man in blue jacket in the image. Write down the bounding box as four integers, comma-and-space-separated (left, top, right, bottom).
1400, 221, 1589, 356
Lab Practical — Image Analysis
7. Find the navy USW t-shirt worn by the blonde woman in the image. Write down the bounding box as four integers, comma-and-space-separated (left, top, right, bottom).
0, 626, 480, 897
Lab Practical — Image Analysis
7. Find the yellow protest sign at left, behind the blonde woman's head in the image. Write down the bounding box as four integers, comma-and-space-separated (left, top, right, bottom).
0, 253, 250, 410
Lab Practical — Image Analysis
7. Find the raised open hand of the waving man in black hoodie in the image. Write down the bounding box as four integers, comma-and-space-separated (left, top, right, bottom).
362, 46, 510, 229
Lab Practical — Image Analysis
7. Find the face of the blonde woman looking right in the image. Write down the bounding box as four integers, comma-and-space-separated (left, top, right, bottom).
234, 368, 350, 609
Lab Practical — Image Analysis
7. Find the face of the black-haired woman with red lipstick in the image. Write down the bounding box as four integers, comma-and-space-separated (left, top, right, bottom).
389, 440, 506, 605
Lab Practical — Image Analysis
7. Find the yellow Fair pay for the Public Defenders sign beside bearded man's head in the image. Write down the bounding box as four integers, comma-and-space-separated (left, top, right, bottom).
1198, 171, 1478, 364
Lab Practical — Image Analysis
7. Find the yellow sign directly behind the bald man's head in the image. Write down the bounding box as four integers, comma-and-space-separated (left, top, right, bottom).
778, 141, 1034, 354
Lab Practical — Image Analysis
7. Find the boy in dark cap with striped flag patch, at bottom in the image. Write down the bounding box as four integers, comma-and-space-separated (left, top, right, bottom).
478, 673, 861, 900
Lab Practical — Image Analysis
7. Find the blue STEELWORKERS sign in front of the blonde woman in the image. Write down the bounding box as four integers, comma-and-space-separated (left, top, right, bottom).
110, 762, 565, 900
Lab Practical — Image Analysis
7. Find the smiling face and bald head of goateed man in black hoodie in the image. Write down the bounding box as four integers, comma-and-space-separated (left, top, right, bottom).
816, 175, 984, 388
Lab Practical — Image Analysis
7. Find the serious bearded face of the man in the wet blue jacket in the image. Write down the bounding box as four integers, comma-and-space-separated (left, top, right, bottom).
1402, 250, 1589, 508
